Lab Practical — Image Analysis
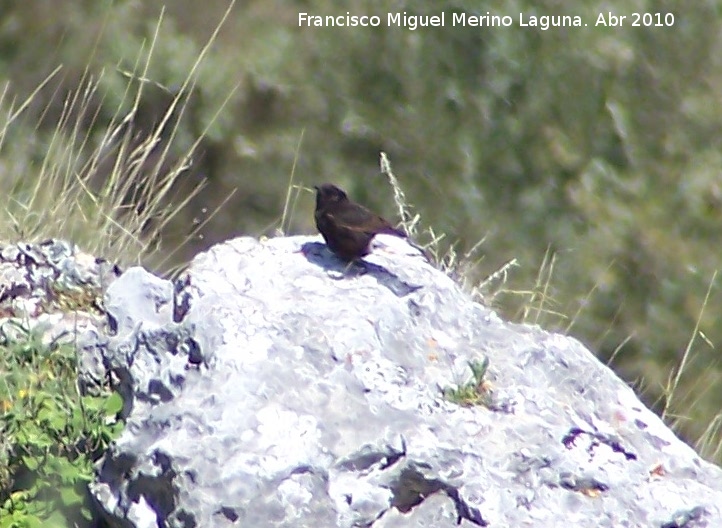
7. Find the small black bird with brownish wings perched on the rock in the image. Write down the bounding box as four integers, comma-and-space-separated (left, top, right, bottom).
314, 183, 406, 261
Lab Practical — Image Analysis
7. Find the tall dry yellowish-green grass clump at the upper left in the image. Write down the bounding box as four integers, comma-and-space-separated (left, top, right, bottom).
0, 4, 232, 269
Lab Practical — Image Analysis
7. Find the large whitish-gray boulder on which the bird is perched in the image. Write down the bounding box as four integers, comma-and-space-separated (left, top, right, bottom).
91, 236, 722, 528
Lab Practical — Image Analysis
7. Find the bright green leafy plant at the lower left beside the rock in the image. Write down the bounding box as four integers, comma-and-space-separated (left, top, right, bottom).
0, 324, 123, 528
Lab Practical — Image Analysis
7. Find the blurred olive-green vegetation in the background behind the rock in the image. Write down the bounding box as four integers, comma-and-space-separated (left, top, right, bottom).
0, 0, 722, 461
